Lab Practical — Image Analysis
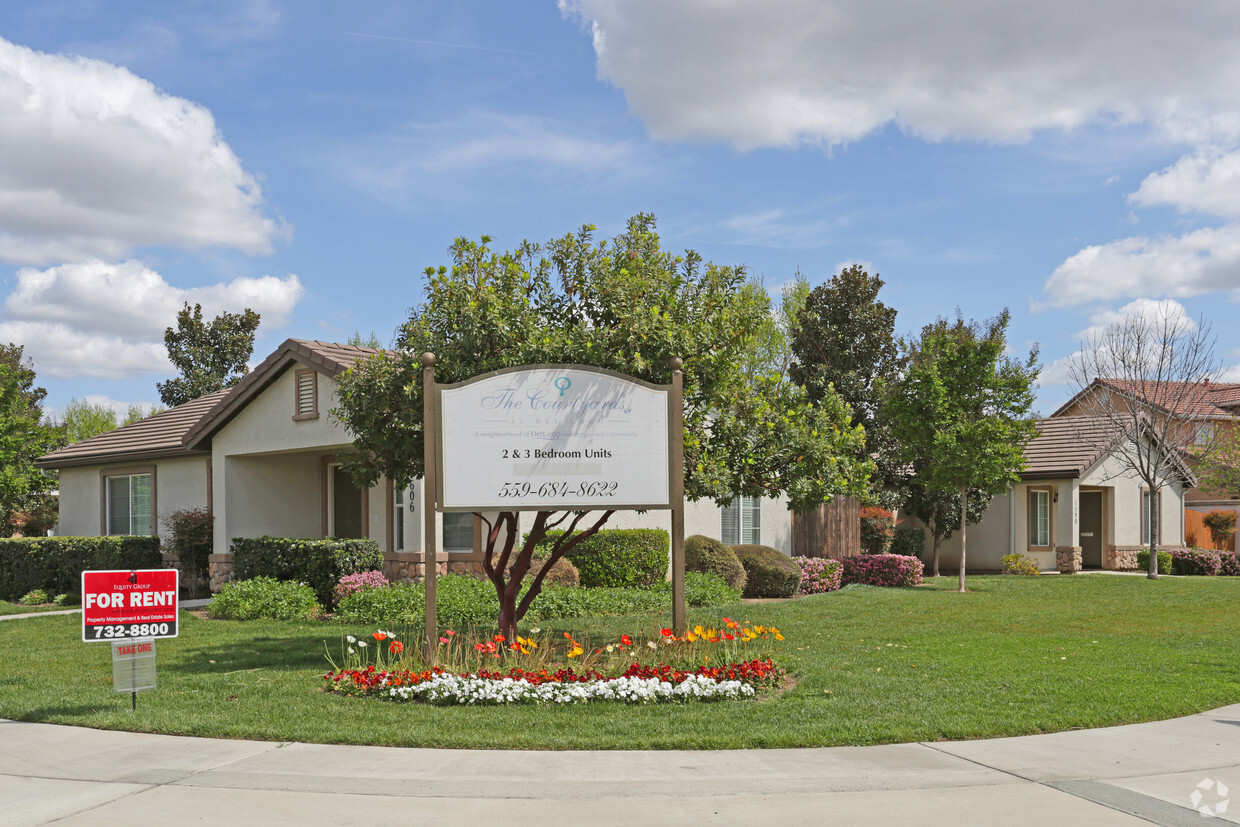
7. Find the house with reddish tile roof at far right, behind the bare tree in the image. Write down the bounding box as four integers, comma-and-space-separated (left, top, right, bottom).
1052, 378, 1240, 542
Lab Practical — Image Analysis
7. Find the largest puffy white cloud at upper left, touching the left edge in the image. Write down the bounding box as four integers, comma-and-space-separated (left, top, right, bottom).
0, 38, 284, 264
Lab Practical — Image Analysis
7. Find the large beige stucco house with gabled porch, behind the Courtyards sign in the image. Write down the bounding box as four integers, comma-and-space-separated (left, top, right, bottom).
37, 338, 791, 589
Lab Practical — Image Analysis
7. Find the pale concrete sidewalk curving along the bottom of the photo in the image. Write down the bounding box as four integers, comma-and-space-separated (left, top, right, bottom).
0, 704, 1240, 827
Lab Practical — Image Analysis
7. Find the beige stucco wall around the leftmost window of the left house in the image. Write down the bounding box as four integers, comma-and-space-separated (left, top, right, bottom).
57, 456, 208, 537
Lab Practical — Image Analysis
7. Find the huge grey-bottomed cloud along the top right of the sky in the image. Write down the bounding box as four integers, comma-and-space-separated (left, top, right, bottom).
559, 0, 1240, 148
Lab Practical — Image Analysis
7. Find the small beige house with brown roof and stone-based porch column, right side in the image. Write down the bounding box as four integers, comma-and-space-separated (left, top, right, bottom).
910, 417, 1195, 570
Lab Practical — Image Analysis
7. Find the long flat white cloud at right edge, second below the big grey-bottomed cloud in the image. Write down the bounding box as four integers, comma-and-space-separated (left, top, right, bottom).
1045, 224, 1240, 307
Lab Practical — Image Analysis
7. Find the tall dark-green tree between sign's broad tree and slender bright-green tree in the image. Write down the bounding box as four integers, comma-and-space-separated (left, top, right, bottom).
790, 264, 904, 507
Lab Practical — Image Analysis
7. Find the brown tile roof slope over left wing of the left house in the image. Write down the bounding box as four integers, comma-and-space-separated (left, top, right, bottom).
35, 388, 229, 469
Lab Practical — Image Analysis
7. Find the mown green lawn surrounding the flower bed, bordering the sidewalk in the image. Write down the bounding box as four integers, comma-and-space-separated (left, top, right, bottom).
0, 575, 1240, 749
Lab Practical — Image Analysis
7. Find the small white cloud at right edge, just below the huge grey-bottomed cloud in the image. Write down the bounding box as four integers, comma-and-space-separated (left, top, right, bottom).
1128, 149, 1240, 218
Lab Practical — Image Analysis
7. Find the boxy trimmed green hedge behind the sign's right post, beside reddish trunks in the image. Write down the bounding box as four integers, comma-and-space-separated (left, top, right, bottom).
536, 528, 668, 589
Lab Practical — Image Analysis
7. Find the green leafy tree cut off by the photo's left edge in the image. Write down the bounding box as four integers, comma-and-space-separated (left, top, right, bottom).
0, 345, 64, 532
